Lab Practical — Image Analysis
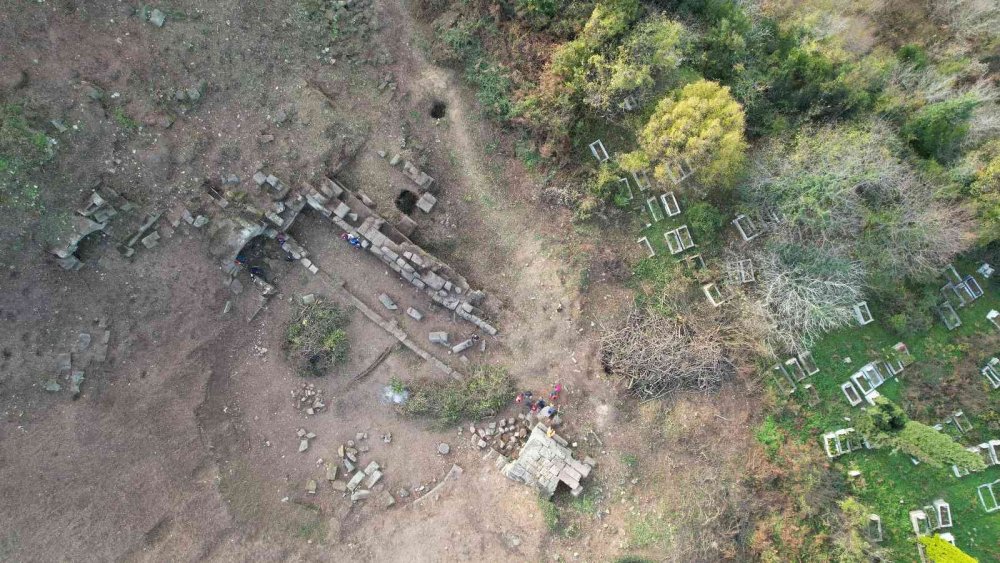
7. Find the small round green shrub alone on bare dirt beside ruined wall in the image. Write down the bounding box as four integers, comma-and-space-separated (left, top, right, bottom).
285, 300, 350, 376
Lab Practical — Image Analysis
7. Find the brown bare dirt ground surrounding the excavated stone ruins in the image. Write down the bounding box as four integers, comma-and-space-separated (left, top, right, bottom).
0, 0, 751, 561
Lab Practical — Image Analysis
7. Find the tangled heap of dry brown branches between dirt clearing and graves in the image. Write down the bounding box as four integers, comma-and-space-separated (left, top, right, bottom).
601, 309, 735, 400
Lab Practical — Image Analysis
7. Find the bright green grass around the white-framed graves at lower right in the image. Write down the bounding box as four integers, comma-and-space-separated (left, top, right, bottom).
777, 263, 1000, 561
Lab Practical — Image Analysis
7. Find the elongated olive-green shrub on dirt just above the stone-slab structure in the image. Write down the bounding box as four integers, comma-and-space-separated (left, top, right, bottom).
401, 365, 515, 425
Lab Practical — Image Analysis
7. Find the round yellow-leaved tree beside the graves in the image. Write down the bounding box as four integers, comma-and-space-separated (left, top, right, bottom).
621, 80, 747, 188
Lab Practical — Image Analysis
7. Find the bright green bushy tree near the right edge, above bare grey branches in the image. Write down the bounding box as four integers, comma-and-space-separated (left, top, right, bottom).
902, 96, 980, 162
